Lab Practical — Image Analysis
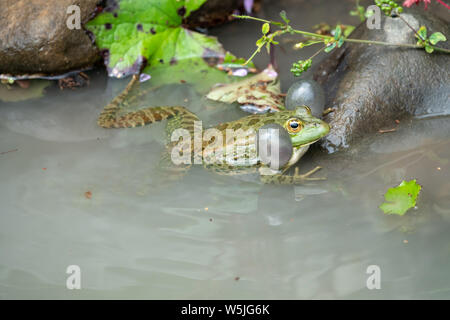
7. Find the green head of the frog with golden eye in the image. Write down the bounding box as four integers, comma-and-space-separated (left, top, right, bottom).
284, 106, 330, 148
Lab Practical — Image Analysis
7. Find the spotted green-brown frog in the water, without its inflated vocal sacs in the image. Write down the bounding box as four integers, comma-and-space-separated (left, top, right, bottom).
98, 78, 330, 184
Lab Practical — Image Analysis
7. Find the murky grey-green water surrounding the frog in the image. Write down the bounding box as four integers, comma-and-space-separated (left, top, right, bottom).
0, 1, 450, 299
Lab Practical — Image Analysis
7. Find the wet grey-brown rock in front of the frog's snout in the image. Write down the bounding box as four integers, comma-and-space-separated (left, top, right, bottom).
314, 9, 450, 152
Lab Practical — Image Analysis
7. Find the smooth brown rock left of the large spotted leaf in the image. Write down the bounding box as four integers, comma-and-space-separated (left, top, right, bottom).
0, 0, 99, 78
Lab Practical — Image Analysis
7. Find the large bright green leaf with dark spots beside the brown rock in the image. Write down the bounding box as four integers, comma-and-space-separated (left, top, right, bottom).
86, 0, 226, 78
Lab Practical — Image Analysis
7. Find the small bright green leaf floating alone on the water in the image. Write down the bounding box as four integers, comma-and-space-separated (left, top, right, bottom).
380, 180, 422, 216
